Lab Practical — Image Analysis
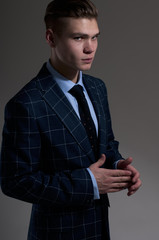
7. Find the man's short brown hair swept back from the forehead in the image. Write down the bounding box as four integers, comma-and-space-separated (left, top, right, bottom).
44, 0, 98, 29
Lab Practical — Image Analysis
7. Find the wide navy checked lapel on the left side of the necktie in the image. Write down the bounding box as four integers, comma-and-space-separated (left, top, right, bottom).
38, 66, 95, 162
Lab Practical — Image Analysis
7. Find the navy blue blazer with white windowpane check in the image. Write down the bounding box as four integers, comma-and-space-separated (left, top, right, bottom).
1, 64, 121, 240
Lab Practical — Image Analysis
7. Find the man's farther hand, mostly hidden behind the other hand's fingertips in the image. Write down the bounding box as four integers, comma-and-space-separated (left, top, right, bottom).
117, 157, 141, 196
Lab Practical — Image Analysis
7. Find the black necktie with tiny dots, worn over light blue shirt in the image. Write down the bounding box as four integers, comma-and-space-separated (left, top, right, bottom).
69, 85, 98, 157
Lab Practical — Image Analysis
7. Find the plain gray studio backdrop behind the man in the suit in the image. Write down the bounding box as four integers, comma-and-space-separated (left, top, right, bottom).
0, 0, 159, 240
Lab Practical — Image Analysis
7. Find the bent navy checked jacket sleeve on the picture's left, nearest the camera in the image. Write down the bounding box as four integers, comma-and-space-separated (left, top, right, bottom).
1, 101, 93, 207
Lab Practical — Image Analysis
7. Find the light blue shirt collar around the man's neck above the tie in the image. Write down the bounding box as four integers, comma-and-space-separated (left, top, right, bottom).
46, 61, 85, 93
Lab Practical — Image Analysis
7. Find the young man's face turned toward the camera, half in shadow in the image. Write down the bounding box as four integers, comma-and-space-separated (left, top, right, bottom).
50, 18, 99, 76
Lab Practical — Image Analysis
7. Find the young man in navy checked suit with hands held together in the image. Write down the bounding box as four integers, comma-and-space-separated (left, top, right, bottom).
1, 0, 141, 240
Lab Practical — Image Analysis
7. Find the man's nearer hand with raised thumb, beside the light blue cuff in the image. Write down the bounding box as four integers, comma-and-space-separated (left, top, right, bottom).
89, 154, 132, 194
